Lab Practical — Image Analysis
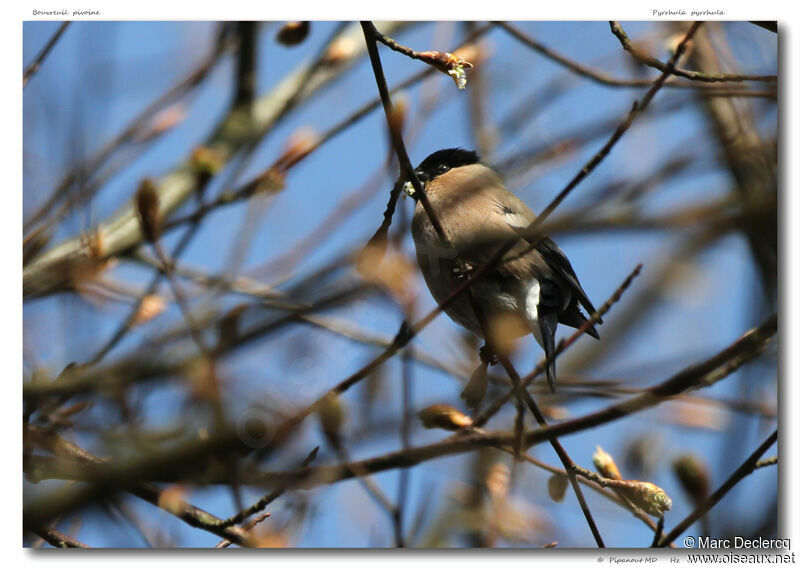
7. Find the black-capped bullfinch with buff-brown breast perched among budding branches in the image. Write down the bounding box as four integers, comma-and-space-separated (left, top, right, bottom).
403, 148, 602, 392
